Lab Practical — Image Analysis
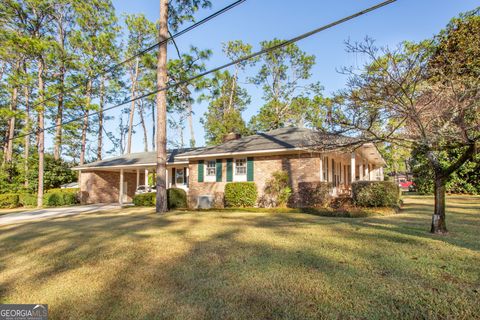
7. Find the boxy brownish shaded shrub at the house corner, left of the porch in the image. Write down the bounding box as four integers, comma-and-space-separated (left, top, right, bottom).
296, 182, 332, 208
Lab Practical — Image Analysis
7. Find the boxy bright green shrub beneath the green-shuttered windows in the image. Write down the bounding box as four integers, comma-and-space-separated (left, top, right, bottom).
225, 182, 258, 207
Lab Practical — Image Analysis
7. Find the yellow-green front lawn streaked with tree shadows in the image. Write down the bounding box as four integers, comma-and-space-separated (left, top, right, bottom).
0, 196, 480, 319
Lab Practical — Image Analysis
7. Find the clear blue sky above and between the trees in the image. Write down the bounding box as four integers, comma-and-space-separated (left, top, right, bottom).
75, 0, 479, 158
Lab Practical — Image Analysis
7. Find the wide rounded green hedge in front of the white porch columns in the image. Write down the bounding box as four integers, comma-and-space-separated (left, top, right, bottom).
352, 181, 400, 207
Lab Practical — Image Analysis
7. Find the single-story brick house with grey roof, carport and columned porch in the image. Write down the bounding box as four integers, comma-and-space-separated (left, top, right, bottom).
74, 128, 385, 208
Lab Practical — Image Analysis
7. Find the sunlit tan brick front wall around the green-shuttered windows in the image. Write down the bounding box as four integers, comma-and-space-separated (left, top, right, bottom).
188, 153, 320, 208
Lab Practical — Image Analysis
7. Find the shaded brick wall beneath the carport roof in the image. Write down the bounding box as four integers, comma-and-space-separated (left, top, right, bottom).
80, 171, 145, 204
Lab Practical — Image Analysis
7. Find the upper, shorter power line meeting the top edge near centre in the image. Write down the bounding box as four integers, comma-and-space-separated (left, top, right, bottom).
23, 0, 246, 112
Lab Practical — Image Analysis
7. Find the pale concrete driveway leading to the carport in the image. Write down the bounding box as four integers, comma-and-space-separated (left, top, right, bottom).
0, 203, 121, 225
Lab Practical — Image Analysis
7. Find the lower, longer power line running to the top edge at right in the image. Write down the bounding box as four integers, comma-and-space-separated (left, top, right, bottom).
12, 0, 397, 139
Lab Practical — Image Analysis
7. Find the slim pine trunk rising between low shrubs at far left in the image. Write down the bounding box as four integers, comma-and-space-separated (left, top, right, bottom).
37, 58, 45, 208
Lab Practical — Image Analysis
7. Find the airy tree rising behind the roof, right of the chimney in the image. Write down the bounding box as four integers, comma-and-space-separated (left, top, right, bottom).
249, 39, 318, 131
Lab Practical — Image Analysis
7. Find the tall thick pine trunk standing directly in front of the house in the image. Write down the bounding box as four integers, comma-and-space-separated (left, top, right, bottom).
155, 0, 168, 213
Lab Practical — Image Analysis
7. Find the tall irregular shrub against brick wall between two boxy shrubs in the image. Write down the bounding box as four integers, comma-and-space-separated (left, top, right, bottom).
260, 171, 292, 207
